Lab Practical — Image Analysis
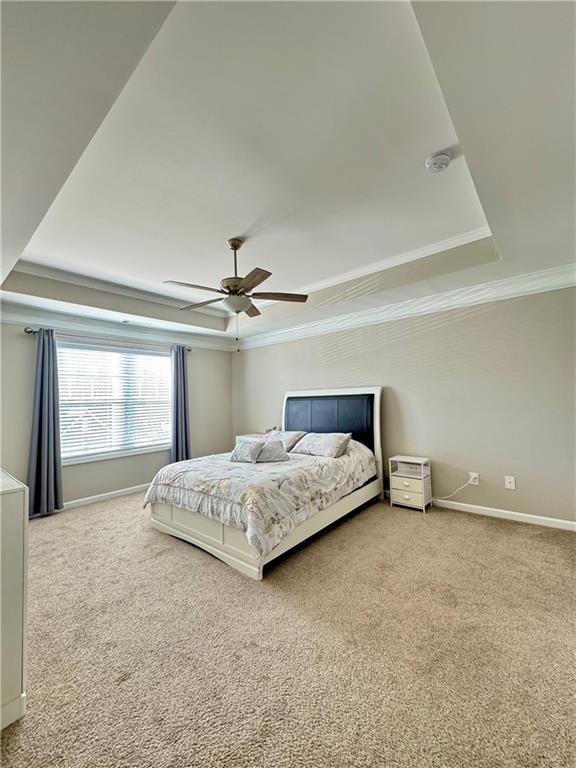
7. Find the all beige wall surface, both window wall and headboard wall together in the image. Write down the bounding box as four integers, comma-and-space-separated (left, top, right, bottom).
1, 289, 576, 519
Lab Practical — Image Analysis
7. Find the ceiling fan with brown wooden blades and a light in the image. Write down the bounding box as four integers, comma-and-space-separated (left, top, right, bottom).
164, 237, 308, 317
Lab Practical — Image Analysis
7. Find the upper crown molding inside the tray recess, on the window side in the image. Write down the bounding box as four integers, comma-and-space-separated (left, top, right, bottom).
12, 261, 228, 317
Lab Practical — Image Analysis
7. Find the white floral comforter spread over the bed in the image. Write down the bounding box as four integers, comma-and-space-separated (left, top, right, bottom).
144, 440, 376, 560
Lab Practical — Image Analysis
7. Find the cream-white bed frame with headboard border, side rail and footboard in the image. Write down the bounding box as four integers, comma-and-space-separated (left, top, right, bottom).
152, 387, 384, 580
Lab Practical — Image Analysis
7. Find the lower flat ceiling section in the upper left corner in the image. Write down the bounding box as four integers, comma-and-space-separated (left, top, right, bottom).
1, 2, 174, 280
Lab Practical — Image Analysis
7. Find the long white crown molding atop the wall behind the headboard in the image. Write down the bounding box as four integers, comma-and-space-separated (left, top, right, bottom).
240, 264, 576, 350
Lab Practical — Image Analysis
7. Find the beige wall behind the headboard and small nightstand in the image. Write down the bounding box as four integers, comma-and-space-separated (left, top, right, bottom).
233, 289, 576, 519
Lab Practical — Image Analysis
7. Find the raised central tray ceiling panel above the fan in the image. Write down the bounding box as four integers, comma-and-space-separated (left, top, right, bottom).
19, 2, 486, 306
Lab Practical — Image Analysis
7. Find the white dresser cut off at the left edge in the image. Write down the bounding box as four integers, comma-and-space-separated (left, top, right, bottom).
0, 469, 28, 728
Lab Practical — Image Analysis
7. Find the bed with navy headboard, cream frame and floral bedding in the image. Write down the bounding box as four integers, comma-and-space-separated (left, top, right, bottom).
145, 387, 383, 579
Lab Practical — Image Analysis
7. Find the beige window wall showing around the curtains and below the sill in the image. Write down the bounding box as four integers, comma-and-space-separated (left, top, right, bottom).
0, 323, 232, 501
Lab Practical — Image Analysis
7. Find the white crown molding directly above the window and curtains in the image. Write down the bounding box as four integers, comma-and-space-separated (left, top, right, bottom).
0, 301, 237, 352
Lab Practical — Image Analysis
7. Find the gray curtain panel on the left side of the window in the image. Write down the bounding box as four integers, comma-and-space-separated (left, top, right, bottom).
28, 328, 63, 517
